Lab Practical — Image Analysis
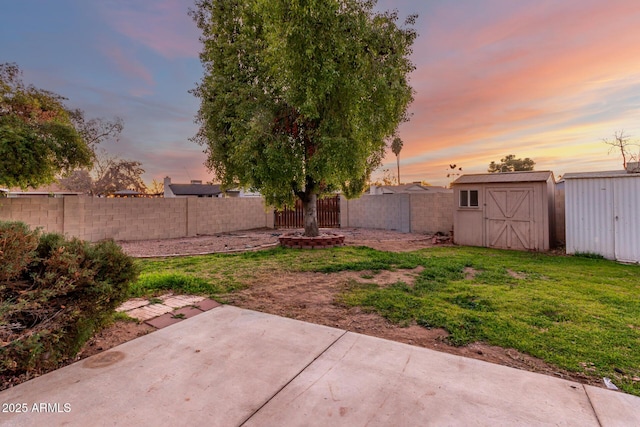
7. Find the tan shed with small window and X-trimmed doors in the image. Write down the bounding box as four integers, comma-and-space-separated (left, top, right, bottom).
452, 171, 555, 251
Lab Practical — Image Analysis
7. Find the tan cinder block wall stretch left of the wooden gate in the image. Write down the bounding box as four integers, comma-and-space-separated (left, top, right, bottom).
0, 197, 273, 242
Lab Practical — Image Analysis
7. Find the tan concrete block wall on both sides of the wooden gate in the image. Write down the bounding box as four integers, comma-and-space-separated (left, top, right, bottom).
0, 193, 453, 242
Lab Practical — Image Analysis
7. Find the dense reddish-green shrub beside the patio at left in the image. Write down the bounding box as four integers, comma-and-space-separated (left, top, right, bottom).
0, 223, 138, 375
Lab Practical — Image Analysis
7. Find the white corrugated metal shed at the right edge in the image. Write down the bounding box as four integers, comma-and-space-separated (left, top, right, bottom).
564, 170, 640, 263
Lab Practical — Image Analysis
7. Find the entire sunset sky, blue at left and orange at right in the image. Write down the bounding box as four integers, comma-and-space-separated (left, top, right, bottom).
0, 0, 640, 185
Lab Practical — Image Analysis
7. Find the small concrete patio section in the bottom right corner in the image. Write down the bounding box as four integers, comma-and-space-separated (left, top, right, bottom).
585, 386, 640, 427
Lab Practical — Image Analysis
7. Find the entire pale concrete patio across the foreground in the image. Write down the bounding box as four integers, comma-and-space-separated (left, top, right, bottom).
0, 306, 640, 427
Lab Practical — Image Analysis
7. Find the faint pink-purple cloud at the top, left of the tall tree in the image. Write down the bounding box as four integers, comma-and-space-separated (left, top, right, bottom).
102, 0, 200, 59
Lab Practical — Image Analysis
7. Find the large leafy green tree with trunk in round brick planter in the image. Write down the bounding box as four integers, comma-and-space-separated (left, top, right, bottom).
191, 0, 416, 236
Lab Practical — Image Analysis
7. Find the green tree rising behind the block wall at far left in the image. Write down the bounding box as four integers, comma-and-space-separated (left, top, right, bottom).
0, 63, 93, 188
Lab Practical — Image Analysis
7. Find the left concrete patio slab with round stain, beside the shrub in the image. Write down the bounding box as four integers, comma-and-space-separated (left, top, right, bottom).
0, 306, 344, 427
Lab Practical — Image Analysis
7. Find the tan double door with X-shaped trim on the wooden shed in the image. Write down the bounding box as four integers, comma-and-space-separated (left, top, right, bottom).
485, 187, 536, 249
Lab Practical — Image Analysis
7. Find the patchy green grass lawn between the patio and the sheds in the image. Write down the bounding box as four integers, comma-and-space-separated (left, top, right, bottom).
132, 247, 640, 395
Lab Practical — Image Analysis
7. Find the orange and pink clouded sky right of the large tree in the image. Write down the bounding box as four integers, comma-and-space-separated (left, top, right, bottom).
387, 0, 640, 183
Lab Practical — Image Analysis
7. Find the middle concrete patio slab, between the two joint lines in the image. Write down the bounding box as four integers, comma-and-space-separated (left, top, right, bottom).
246, 333, 599, 426
